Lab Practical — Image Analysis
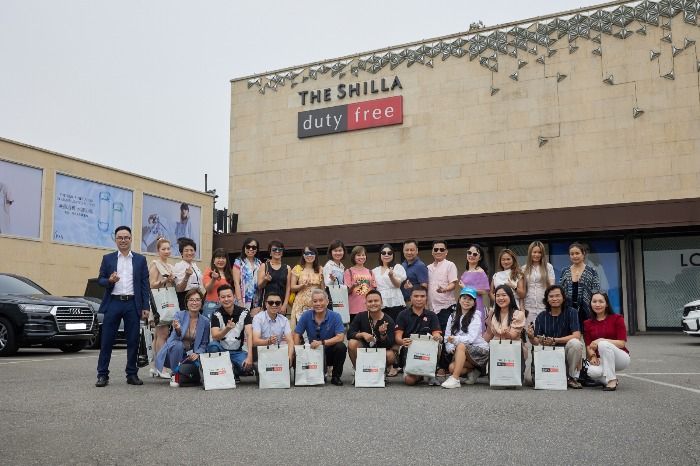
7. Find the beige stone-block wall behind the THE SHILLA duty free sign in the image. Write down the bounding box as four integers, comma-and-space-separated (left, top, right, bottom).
229, 14, 700, 231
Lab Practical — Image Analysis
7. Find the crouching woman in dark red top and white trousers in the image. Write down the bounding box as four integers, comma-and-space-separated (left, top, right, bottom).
583, 293, 630, 392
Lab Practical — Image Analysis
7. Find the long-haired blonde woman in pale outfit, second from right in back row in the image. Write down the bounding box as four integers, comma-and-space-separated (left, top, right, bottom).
523, 241, 556, 326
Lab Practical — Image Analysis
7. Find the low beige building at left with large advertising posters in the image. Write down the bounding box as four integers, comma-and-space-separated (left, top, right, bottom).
0, 139, 214, 296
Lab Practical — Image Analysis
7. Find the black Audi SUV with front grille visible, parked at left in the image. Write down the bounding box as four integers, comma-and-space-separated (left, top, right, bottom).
0, 273, 98, 356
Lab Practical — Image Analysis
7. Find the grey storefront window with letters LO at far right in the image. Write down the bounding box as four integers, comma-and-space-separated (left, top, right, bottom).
642, 236, 700, 329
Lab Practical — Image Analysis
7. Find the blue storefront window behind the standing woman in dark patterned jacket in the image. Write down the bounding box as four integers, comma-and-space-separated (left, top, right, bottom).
550, 240, 622, 314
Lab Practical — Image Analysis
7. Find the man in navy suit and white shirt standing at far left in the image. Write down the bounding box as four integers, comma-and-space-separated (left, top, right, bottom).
95, 226, 150, 387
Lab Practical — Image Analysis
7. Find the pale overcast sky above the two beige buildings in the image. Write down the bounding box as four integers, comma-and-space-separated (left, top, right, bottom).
0, 0, 599, 208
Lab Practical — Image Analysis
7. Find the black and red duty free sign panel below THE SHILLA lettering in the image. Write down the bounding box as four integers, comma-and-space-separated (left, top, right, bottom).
297, 95, 403, 138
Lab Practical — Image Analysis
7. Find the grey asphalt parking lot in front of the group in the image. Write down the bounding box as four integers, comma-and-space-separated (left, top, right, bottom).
0, 335, 700, 465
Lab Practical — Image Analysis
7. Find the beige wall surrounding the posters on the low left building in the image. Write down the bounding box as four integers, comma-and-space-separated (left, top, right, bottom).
0, 140, 213, 295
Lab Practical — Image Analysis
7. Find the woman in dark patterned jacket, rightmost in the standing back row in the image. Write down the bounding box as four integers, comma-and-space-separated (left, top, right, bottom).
559, 243, 600, 328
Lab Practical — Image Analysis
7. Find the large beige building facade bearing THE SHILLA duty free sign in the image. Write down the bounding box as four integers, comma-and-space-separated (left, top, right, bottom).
219, 0, 700, 332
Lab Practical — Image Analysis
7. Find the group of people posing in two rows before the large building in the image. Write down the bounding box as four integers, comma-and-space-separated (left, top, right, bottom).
96, 227, 629, 391
